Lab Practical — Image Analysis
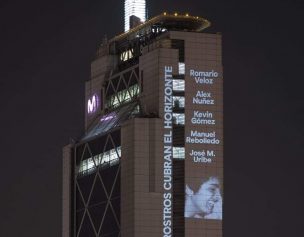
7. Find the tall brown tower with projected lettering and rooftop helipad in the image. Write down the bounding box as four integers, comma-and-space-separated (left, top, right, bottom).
62, 13, 223, 237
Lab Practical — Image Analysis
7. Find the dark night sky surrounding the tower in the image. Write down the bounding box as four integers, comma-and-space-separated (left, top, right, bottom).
0, 0, 304, 237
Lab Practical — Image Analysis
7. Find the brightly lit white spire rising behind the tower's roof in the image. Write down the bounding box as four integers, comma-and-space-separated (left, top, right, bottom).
125, 0, 146, 31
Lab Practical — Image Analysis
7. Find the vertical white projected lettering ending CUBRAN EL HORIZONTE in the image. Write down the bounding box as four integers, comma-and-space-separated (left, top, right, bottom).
163, 66, 173, 237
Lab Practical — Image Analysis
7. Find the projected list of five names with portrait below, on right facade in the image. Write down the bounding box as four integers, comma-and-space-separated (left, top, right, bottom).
184, 69, 223, 226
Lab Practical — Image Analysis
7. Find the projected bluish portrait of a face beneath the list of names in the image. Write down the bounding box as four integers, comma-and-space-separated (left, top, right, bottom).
185, 177, 223, 220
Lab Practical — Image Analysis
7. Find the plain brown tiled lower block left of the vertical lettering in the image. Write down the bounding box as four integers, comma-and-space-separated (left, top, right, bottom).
121, 118, 163, 237
